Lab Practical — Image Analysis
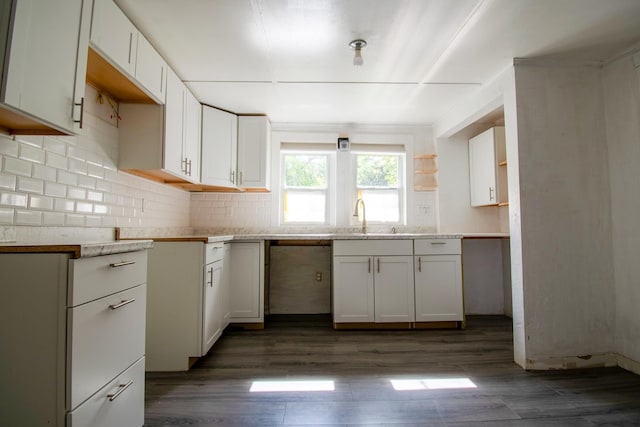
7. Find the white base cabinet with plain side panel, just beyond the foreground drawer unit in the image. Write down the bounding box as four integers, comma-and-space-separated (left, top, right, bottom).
146, 241, 229, 371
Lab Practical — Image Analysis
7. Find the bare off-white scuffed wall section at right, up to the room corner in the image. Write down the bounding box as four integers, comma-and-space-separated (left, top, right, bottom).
509, 61, 615, 369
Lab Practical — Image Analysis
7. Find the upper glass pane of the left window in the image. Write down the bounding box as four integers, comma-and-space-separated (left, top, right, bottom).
284, 154, 328, 188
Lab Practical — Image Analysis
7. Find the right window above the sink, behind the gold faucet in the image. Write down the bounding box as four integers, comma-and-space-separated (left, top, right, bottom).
352, 153, 404, 224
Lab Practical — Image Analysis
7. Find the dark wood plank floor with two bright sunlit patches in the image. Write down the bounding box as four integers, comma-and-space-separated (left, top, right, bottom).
145, 316, 640, 427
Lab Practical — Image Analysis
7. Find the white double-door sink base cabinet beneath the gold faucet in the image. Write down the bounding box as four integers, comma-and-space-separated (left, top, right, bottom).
333, 240, 415, 328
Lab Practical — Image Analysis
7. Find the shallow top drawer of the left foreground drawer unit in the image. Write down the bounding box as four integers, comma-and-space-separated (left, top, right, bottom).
68, 251, 147, 307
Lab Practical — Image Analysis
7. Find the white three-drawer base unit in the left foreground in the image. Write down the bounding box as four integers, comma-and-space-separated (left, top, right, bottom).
0, 242, 151, 427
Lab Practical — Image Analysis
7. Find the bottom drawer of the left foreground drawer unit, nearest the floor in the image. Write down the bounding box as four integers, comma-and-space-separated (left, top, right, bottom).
67, 357, 144, 427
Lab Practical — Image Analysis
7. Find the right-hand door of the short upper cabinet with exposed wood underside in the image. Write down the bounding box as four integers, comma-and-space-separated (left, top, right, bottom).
136, 33, 167, 104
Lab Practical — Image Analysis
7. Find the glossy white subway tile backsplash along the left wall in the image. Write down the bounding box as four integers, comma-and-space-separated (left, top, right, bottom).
0, 86, 189, 240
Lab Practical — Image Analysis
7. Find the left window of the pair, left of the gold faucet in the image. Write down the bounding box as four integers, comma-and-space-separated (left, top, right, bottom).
282, 151, 329, 224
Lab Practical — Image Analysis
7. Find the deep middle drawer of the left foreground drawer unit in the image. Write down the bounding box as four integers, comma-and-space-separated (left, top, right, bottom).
67, 285, 147, 409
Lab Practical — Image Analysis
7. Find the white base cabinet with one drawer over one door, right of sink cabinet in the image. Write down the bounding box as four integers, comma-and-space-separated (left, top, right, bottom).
414, 239, 464, 322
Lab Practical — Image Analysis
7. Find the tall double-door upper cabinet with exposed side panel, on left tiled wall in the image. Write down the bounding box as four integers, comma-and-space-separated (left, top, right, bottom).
118, 69, 201, 184
